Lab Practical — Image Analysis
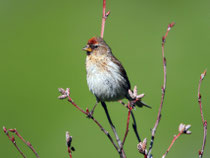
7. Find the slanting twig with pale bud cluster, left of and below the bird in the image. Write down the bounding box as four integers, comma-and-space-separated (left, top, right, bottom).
58, 88, 119, 153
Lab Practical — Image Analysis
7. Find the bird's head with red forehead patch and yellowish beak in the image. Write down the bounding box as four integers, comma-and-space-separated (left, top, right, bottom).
83, 37, 110, 55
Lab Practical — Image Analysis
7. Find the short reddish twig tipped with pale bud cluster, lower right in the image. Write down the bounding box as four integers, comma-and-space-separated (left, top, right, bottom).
162, 123, 192, 158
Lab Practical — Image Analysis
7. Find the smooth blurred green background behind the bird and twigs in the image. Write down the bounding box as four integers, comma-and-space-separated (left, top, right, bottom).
0, 0, 210, 158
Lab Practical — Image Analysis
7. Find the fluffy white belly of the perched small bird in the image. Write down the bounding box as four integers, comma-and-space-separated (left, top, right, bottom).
87, 58, 127, 101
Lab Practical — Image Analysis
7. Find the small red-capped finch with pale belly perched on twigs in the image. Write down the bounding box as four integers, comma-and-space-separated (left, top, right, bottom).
83, 37, 149, 114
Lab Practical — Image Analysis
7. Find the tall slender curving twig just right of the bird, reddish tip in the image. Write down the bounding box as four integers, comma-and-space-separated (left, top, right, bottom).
148, 22, 175, 158
